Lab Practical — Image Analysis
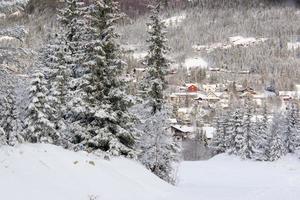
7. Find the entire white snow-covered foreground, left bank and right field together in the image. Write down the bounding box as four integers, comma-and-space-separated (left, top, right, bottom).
0, 144, 300, 200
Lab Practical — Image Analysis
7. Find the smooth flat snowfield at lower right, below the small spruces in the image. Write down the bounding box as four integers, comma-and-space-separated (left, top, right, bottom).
174, 154, 300, 200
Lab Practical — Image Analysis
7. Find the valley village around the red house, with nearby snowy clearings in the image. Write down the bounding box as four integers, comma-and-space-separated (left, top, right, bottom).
123, 32, 300, 160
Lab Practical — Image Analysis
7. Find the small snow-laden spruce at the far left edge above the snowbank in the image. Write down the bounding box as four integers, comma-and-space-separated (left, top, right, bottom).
0, 91, 23, 146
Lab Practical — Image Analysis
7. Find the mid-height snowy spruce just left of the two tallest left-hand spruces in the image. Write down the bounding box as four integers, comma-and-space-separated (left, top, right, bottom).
42, 34, 71, 147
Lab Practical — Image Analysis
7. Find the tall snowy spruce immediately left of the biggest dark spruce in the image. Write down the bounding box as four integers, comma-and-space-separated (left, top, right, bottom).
58, 0, 88, 125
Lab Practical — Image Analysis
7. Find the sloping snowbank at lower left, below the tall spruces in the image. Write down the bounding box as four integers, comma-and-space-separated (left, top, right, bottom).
0, 144, 173, 200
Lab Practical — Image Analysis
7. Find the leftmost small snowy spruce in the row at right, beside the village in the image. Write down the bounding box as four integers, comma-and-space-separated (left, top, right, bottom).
210, 113, 230, 154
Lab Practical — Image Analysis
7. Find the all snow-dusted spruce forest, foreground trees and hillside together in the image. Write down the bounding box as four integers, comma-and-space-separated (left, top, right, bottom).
0, 0, 300, 184
